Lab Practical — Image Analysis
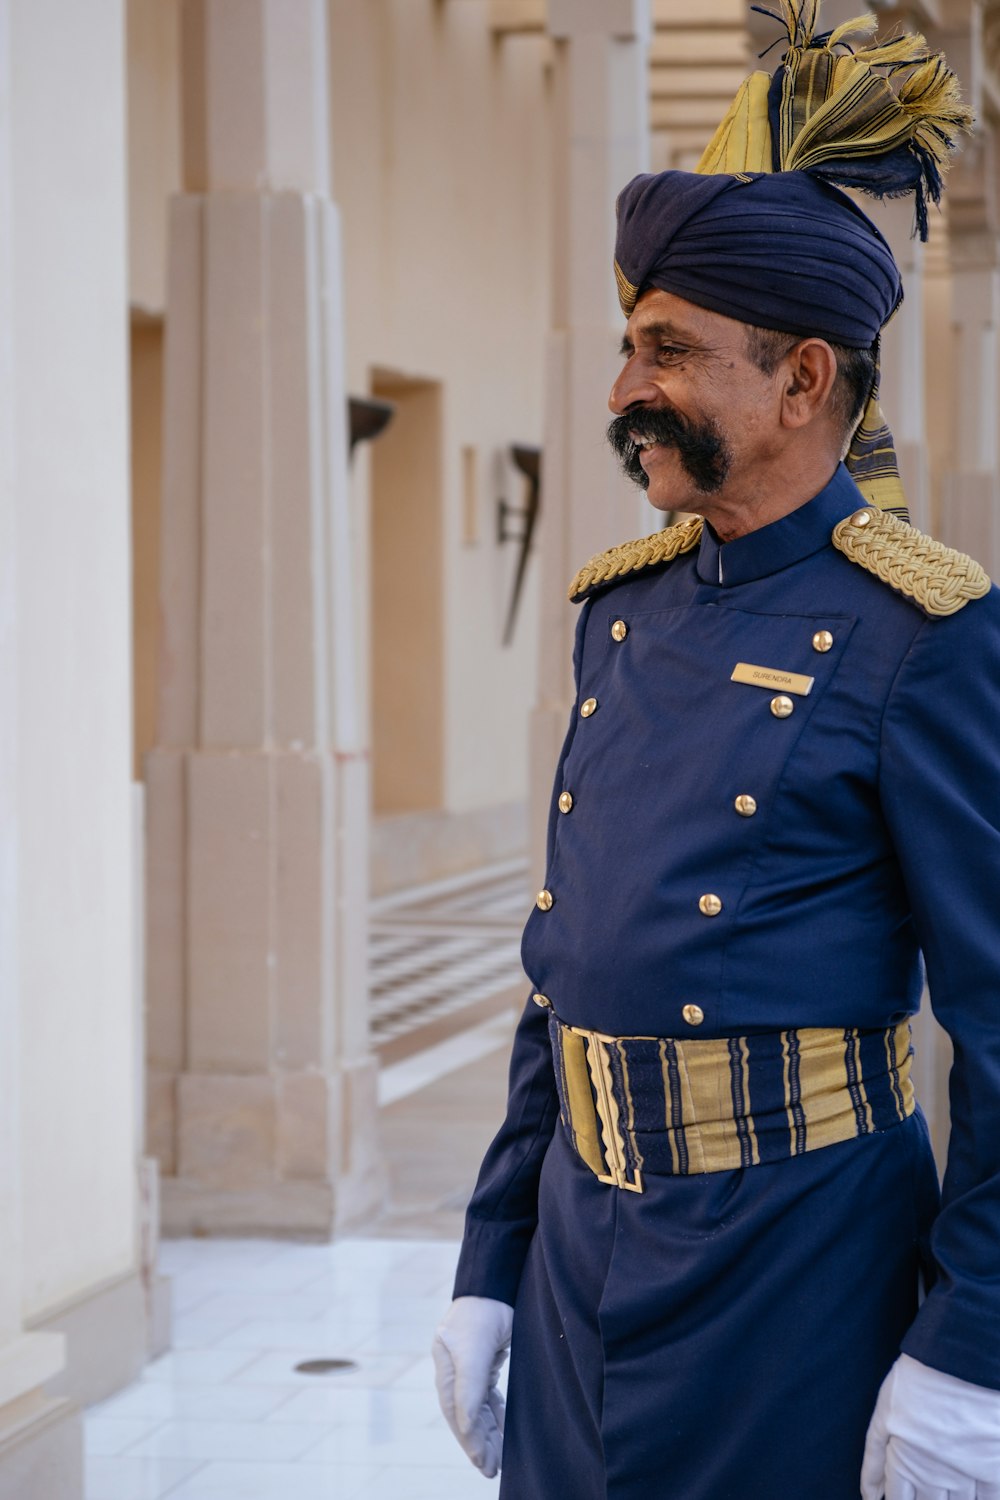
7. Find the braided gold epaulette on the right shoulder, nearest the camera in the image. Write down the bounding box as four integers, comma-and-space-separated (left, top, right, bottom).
831, 506, 990, 615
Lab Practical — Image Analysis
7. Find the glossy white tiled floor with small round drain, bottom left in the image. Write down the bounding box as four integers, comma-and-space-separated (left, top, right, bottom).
85, 1239, 496, 1500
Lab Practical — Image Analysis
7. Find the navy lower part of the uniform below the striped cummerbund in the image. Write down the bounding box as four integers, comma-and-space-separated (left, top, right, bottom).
501, 1112, 939, 1500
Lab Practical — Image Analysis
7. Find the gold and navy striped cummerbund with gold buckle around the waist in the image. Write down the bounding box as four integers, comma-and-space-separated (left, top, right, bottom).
549, 1014, 915, 1193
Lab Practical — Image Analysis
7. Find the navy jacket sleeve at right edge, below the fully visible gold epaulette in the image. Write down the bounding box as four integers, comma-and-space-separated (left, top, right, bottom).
880, 588, 1000, 1389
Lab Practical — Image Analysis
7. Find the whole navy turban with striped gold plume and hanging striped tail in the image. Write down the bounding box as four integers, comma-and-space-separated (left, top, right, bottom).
615, 0, 972, 516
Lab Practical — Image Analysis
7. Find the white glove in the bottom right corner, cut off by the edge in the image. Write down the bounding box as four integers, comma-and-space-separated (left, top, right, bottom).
861, 1355, 1000, 1500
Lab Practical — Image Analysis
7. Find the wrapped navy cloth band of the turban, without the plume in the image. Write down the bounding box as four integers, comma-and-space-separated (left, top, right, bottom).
615, 171, 903, 348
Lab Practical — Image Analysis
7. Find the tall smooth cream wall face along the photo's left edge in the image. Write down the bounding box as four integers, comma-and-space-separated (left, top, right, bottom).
10, 0, 138, 1319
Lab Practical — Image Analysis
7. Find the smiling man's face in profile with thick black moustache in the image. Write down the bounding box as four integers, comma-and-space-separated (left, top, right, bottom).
609, 290, 781, 519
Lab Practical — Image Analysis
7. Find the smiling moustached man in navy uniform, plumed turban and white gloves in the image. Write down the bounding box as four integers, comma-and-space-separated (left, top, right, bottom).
435, 0, 1000, 1500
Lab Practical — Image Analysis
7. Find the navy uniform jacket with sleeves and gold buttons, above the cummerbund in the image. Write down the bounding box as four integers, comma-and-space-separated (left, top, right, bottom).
456, 468, 1000, 1389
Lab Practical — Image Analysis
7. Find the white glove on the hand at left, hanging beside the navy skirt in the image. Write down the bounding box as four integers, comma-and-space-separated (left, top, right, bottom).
430, 1298, 514, 1479
